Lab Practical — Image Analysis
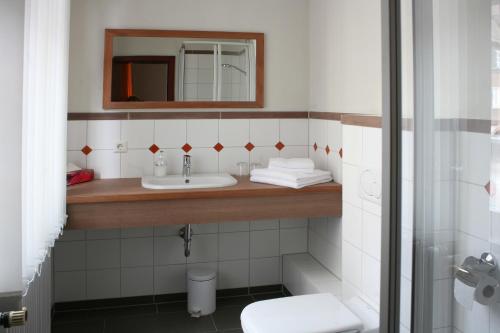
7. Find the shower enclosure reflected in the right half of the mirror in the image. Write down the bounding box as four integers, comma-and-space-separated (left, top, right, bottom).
177, 40, 256, 101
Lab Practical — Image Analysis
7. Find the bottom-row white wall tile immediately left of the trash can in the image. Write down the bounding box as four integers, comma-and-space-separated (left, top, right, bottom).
154, 265, 186, 295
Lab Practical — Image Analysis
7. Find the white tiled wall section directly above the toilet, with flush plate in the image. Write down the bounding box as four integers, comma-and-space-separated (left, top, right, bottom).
342, 124, 382, 309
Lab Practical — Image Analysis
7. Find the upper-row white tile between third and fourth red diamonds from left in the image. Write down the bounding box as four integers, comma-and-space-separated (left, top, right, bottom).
187, 119, 219, 148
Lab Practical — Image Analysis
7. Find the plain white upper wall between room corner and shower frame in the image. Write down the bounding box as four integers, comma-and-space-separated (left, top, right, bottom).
309, 0, 382, 115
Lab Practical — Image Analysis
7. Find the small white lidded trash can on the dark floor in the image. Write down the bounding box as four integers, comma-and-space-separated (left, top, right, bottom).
187, 268, 217, 317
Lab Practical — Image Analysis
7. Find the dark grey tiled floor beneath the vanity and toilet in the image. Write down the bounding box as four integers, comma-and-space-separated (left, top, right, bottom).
52, 292, 285, 333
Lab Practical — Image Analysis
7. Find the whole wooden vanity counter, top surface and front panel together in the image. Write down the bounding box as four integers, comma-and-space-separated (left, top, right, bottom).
67, 177, 342, 229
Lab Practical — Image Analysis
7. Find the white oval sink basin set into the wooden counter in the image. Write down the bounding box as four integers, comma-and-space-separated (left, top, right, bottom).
142, 173, 238, 190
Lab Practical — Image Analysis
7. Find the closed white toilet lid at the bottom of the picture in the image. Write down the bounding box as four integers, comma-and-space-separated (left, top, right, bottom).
241, 294, 363, 333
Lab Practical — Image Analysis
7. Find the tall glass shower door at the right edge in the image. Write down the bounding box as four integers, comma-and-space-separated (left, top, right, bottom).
399, 0, 500, 333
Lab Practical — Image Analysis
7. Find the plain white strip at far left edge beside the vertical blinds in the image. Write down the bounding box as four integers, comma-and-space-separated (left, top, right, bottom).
0, 0, 24, 294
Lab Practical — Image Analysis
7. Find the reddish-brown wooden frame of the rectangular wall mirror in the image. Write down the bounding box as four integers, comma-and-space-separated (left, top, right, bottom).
102, 29, 264, 109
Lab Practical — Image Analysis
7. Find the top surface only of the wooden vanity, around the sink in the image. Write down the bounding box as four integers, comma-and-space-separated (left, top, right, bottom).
66, 177, 342, 205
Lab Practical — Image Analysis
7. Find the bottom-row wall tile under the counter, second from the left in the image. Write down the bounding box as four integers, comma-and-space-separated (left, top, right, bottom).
87, 269, 120, 300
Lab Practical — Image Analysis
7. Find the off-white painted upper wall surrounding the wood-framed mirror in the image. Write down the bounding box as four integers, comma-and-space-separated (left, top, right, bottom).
69, 0, 309, 112
